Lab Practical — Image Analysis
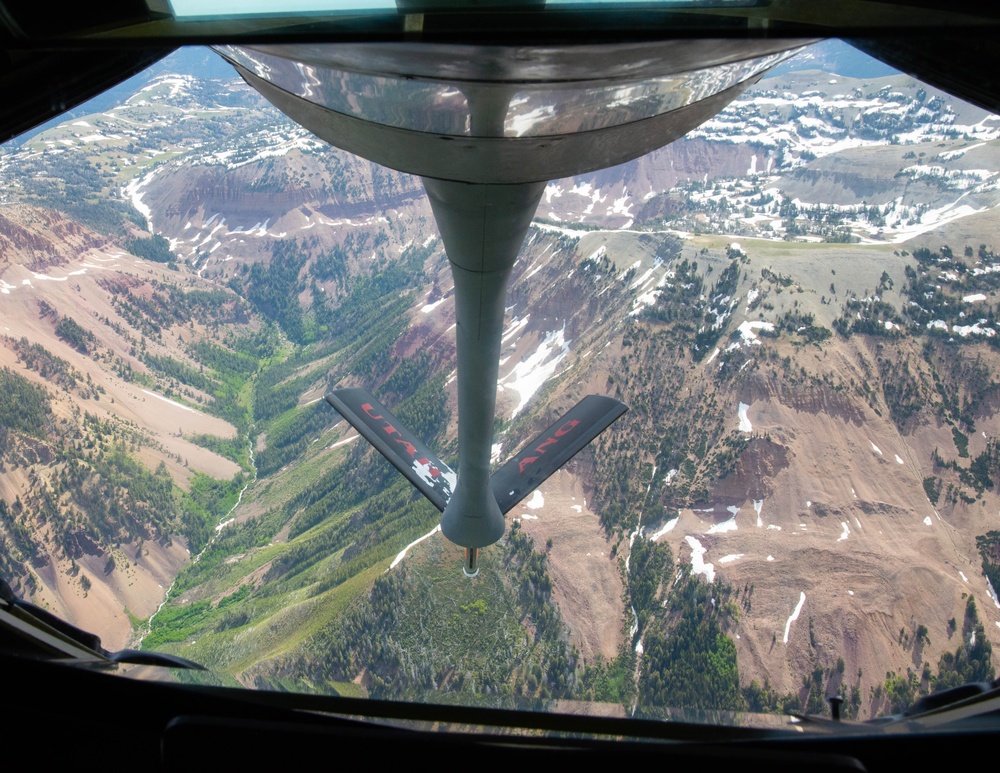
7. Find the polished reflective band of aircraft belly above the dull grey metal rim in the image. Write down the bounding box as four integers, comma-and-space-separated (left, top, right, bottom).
218, 41, 795, 139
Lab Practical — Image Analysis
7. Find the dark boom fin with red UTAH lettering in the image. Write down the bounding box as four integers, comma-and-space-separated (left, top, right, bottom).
326, 389, 456, 511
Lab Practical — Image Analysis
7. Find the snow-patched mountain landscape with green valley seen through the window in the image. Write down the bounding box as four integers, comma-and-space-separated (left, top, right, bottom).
0, 43, 1000, 718
